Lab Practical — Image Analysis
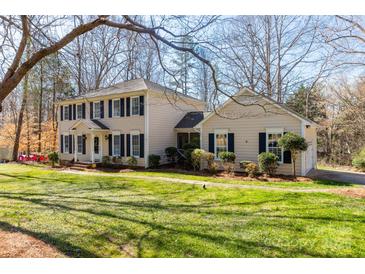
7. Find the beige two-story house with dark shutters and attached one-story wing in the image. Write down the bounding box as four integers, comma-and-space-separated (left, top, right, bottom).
58, 79, 317, 175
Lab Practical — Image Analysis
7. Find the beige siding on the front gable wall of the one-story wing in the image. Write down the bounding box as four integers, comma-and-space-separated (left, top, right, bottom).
202, 93, 301, 174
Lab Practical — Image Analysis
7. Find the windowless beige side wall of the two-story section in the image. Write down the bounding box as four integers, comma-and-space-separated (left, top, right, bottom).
148, 92, 204, 162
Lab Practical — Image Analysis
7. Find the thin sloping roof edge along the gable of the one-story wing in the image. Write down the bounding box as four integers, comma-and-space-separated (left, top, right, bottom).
195, 88, 318, 127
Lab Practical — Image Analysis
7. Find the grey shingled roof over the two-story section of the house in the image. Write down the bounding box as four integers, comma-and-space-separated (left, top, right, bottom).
59, 78, 203, 105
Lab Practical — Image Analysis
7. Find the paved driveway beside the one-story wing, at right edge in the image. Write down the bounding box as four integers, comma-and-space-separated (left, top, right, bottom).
308, 169, 365, 185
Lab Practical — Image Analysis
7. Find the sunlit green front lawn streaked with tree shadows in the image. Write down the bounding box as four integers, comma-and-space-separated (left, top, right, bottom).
0, 164, 365, 257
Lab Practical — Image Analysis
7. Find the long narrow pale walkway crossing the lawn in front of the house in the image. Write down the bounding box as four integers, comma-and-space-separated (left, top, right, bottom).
61, 170, 333, 193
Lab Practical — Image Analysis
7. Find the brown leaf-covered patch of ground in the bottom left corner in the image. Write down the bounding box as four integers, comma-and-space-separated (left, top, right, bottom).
0, 230, 65, 258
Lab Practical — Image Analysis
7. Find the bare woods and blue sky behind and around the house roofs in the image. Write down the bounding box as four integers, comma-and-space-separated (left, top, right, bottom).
0, 16, 365, 167
